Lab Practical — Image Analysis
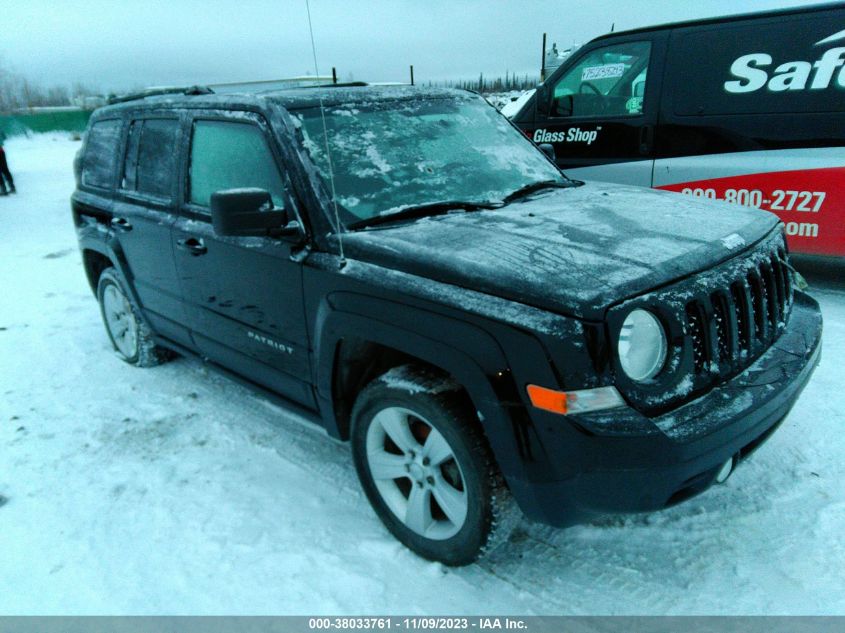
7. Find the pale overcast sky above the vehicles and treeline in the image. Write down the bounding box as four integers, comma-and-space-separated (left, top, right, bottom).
0, 0, 828, 90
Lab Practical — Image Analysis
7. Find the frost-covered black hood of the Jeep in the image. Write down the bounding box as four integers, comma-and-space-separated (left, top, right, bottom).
336, 183, 778, 319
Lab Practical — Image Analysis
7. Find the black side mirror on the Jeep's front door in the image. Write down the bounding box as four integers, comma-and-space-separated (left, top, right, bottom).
211, 188, 302, 237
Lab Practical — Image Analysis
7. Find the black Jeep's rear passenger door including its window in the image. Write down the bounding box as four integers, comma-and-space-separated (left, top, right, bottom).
111, 114, 190, 345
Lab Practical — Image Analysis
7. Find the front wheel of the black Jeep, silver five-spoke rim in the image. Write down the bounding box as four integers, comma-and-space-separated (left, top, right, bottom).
352, 365, 520, 565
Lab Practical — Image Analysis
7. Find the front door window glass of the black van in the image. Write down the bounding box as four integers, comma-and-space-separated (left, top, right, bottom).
550, 42, 651, 117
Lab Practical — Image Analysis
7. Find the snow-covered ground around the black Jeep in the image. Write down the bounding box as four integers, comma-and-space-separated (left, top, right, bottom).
0, 135, 845, 614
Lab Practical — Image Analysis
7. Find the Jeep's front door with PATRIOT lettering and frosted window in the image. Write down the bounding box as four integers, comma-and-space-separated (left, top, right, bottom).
173, 112, 315, 407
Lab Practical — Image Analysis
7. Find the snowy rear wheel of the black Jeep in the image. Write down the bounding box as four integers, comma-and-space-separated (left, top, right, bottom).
97, 268, 170, 367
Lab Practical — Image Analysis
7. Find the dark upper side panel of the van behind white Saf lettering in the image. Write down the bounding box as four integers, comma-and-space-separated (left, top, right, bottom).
668, 11, 845, 116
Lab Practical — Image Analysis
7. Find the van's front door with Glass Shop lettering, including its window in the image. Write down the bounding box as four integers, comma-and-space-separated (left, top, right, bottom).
521, 33, 665, 187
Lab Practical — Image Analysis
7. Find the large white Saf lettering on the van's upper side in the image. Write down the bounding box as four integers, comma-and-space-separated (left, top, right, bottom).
724, 37, 845, 94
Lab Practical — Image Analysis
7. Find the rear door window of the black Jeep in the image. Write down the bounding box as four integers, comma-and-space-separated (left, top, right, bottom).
120, 119, 179, 199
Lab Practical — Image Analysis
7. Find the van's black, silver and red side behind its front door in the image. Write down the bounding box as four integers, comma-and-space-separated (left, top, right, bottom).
654, 5, 845, 256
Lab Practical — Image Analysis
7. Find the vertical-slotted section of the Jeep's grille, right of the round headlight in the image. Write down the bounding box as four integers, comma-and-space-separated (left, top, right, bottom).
685, 247, 792, 375
